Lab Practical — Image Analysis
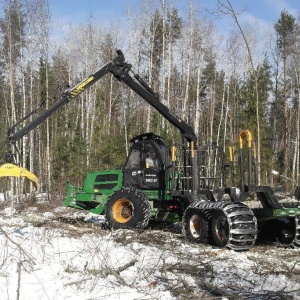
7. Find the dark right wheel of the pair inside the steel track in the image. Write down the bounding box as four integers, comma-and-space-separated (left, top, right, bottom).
211, 210, 230, 248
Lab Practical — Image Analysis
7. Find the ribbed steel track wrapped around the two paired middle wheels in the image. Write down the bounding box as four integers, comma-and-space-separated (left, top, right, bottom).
183, 201, 258, 251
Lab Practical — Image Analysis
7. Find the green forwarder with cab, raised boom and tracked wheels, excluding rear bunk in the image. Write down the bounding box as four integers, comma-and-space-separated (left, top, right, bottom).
2, 50, 298, 250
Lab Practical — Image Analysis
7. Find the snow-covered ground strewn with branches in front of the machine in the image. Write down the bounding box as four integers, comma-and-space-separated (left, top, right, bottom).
0, 200, 300, 300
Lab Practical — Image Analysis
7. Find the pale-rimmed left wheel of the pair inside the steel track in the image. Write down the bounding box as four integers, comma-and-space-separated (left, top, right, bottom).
182, 207, 209, 243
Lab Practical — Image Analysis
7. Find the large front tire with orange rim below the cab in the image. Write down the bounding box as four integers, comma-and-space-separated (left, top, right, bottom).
105, 187, 151, 229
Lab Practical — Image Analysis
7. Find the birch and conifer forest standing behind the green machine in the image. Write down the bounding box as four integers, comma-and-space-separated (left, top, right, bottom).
0, 0, 300, 197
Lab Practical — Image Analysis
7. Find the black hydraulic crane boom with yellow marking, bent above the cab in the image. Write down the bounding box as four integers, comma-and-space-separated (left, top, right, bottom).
6, 50, 198, 189
